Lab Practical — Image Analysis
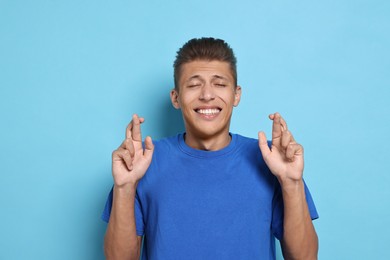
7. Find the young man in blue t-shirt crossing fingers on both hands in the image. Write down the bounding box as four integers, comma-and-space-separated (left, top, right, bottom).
103, 38, 318, 259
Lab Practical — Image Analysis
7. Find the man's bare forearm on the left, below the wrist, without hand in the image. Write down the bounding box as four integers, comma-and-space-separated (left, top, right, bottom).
104, 185, 140, 259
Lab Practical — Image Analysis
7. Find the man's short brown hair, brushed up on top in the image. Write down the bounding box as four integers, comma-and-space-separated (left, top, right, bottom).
173, 37, 237, 90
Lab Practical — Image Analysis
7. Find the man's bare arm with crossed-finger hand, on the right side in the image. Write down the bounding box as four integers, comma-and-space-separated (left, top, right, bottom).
259, 113, 318, 260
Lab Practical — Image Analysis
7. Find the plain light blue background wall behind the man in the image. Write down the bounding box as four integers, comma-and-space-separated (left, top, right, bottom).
0, 0, 390, 260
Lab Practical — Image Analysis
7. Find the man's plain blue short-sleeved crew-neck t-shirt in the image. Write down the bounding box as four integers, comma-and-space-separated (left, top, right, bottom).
102, 134, 318, 260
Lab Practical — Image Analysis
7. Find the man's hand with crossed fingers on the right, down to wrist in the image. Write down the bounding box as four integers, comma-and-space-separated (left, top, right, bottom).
259, 113, 304, 182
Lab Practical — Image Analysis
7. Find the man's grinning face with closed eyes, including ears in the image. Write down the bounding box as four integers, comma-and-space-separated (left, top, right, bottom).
171, 60, 241, 139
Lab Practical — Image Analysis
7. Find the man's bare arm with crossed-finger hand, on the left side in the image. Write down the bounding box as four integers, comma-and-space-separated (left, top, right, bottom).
104, 115, 154, 260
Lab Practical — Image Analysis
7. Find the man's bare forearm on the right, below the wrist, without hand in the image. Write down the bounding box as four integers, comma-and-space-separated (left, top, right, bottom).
281, 181, 318, 260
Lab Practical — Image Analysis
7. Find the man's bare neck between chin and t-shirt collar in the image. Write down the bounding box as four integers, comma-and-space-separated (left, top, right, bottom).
184, 132, 232, 151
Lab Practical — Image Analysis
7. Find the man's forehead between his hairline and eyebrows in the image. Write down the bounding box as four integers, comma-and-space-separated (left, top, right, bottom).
180, 60, 234, 82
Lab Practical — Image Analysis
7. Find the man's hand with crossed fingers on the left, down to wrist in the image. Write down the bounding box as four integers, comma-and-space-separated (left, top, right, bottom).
112, 115, 154, 187
